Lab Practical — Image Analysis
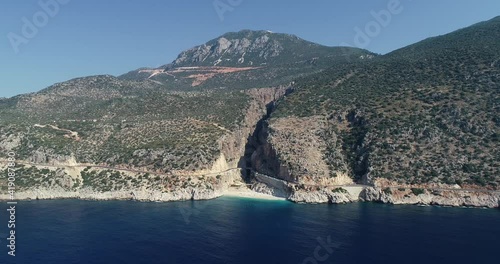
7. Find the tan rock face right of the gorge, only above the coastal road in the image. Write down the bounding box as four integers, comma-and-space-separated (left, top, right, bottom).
252, 117, 352, 185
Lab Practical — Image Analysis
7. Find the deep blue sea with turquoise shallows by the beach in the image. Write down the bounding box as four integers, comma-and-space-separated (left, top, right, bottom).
0, 198, 500, 264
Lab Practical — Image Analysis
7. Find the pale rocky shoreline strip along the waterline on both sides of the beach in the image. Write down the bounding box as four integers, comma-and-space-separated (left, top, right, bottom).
0, 182, 500, 208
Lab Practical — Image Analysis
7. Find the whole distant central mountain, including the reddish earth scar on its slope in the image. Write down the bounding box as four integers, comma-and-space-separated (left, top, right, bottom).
119, 30, 375, 90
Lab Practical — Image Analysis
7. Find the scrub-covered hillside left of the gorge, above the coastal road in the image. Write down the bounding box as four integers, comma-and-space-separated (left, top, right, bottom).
0, 83, 249, 172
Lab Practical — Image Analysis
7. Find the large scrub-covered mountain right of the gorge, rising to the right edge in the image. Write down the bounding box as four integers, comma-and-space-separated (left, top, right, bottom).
260, 17, 500, 193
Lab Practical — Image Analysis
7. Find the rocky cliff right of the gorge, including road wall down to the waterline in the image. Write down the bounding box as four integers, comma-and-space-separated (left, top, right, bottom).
245, 108, 361, 203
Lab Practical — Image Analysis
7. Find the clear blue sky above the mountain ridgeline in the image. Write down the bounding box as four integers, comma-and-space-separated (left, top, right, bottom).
0, 0, 500, 97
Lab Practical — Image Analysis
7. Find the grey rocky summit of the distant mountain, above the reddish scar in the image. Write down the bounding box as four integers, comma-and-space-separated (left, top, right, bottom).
170, 30, 375, 69
